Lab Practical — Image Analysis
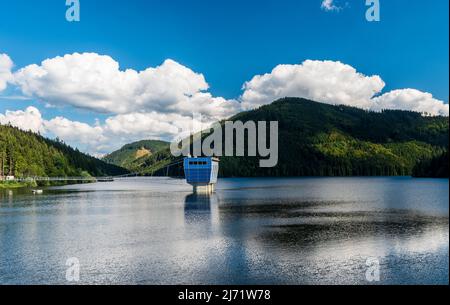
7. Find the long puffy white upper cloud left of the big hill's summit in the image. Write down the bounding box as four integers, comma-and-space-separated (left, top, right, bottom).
14, 53, 237, 118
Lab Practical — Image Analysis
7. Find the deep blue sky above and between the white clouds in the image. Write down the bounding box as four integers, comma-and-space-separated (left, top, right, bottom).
0, 0, 449, 152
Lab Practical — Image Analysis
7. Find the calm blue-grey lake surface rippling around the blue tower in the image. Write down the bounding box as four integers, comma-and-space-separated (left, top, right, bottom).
0, 178, 449, 284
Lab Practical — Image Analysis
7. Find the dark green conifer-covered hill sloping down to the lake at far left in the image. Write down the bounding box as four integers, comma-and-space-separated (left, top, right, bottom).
0, 125, 127, 177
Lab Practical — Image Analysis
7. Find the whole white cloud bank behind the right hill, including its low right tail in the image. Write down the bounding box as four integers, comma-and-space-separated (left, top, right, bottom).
241, 60, 449, 116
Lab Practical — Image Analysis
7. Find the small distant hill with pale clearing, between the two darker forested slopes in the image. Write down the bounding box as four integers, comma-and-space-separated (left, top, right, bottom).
103, 140, 169, 169
